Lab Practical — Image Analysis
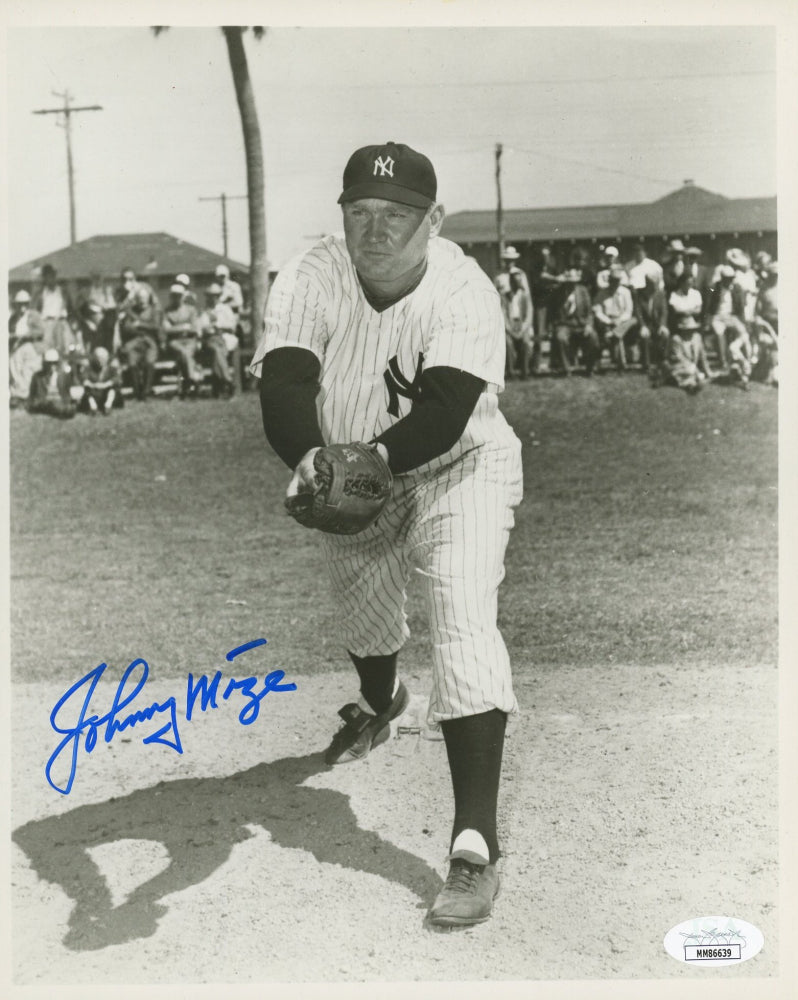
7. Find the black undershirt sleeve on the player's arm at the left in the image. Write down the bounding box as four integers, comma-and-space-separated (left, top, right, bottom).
260, 347, 325, 469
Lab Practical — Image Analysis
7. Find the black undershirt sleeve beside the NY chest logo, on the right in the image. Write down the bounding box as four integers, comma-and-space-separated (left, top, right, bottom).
376, 366, 485, 473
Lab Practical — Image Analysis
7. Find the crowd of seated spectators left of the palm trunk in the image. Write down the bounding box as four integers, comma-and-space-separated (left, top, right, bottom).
8, 264, 245, 418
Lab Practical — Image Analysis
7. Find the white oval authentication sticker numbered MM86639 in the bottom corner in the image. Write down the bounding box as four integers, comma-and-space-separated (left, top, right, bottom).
663, 917, 765, 967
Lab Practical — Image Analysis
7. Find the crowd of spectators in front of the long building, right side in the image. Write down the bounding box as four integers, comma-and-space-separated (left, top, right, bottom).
495, 239, 779, 393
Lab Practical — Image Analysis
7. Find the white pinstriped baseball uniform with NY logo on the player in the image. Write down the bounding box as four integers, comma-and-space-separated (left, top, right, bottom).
251, 236, 522, 723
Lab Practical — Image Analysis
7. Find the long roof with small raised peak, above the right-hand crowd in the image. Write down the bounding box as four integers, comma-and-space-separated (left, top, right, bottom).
441, 182, 776, 243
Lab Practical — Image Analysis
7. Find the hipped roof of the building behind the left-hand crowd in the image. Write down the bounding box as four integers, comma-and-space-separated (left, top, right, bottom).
8, 233, 249, 282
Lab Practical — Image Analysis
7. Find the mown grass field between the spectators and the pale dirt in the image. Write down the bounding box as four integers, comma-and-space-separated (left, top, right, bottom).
10, 374, 777, 680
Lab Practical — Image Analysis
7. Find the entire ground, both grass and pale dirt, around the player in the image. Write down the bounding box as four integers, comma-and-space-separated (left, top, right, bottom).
6, 384, 780, 997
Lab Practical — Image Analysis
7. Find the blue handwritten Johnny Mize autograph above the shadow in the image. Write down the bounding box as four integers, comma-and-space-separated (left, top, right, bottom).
44, 639, 296, 795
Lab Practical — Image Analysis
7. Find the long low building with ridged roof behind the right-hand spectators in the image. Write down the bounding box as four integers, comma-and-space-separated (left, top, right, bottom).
441, 181, 777, 276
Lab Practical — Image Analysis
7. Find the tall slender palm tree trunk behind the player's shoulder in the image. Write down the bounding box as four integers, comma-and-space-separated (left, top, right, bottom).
222, 27, 269, 352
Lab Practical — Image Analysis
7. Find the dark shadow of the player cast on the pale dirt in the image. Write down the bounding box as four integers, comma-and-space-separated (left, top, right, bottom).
13, 754, 441, 951
